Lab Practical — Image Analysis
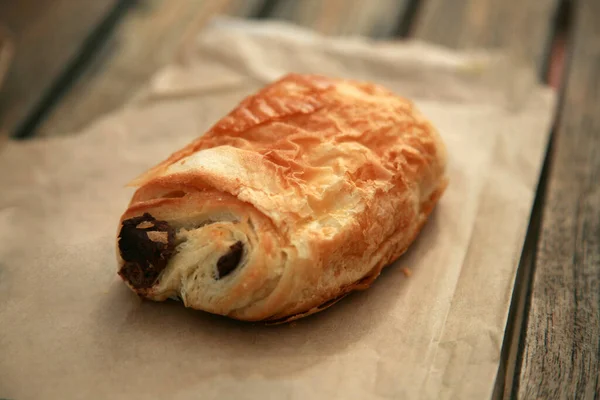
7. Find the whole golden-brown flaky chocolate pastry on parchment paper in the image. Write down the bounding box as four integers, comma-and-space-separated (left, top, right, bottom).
117, 74, 447, 321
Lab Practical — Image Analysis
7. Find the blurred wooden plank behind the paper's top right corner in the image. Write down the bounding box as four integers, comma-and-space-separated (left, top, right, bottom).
414, 0, 558, 73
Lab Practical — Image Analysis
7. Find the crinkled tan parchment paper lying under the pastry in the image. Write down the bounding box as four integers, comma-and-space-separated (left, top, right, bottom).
0, 19, 554, 400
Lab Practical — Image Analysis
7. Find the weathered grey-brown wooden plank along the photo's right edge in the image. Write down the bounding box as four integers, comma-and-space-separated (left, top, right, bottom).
517, 0, 600, 399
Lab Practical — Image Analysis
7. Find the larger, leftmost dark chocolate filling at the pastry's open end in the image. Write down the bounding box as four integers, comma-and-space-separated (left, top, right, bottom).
119, 213, 175, 289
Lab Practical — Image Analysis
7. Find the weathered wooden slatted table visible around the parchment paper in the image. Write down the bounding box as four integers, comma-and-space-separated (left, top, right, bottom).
0, 0, 600, 399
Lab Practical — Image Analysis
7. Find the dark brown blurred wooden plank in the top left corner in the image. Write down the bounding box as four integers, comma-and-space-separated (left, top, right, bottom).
0, 0, 118, 136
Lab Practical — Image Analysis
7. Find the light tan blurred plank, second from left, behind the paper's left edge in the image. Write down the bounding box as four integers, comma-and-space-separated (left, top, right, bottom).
37, 0, 260, 136
